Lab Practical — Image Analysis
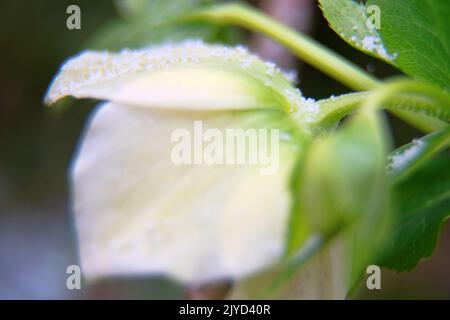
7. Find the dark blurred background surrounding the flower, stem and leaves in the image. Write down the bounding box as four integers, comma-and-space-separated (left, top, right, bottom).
0, 0, 450, 299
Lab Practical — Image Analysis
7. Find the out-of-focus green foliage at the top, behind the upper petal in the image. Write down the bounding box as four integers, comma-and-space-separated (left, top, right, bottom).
87, 0, 240, 50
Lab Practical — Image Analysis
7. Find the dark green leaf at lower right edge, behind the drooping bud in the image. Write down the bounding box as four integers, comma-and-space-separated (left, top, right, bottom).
379, 153, 450, 271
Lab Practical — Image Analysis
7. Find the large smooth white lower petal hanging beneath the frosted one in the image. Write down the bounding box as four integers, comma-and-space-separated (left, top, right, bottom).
72, 103, 295, 282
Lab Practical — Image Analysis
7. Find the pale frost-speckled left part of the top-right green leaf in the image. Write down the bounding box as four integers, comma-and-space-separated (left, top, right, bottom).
319, 0, 395, 63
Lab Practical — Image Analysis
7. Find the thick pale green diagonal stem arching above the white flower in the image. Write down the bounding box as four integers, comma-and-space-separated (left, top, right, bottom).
189, 4, 379, 90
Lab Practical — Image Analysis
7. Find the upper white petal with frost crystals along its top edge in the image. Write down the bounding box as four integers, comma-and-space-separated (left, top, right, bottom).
45, 41, 302, 111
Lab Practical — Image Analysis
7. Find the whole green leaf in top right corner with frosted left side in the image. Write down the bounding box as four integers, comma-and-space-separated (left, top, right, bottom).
319, 0, 450, 90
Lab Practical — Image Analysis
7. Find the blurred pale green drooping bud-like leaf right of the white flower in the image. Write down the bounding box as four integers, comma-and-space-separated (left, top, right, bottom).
287, 109, 389, 288
